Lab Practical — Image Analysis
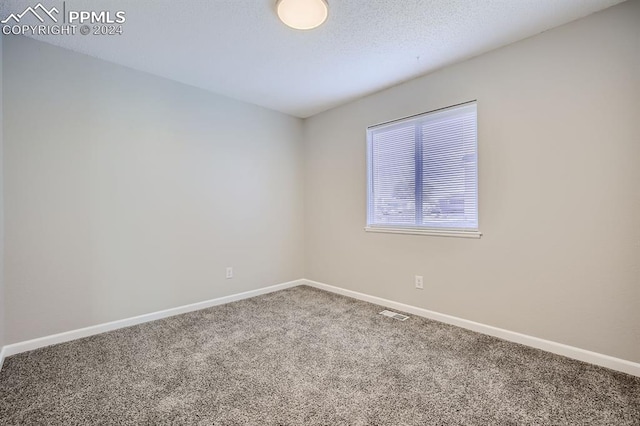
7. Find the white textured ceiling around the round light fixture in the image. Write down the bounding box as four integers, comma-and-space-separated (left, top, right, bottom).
0, 0, 621, 117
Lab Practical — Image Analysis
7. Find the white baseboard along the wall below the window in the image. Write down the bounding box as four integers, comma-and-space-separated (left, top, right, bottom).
303, 279, 640, 377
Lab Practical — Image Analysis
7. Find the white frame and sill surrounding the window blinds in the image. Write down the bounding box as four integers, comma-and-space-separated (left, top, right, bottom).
364, 100, 482, 238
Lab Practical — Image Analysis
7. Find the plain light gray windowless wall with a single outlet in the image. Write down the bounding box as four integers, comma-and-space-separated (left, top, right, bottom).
4, 36, 304, 344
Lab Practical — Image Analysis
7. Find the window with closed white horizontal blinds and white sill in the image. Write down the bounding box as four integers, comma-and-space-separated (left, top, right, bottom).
366, 102, 481, 237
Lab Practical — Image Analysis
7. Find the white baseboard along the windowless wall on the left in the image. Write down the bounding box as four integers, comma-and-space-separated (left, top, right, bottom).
0, 280, 304, 362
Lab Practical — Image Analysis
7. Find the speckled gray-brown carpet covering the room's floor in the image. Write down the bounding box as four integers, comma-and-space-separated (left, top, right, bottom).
0, 287, 640, 425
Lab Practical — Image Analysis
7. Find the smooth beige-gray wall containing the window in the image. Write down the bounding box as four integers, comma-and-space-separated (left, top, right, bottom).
305, 1, 640, 362
